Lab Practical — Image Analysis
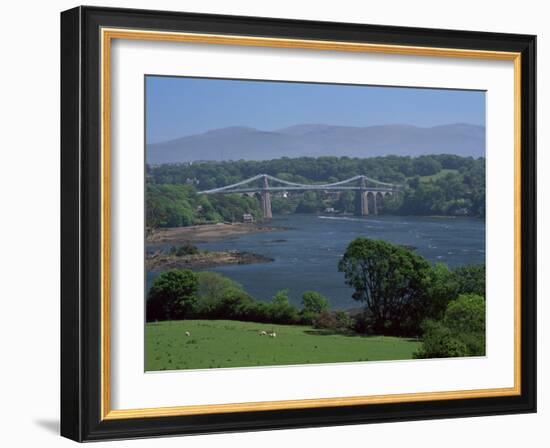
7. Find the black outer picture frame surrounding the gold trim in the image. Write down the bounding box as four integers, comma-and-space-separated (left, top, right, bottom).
61, 7, 536, 441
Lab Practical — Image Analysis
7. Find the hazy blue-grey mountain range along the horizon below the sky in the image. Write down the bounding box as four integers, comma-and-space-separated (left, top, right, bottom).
147, 123, 485, 164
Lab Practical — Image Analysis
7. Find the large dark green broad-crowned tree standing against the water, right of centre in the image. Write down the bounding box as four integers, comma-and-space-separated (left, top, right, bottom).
338, 238, 431, 334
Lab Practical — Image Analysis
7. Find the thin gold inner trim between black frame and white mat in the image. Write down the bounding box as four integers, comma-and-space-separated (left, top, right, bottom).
100, 28, 521, 420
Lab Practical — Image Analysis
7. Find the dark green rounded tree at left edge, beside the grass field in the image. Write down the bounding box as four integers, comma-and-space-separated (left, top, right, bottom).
147, 269, 198, 321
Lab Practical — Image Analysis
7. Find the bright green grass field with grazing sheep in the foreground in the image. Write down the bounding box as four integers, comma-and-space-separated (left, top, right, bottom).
145, 320, 420, 371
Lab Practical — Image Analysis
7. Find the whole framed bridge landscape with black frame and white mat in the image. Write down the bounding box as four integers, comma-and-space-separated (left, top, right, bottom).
61, 7, 536, 441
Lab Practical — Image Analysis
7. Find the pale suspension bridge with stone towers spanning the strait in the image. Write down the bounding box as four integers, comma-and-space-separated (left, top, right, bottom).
199, 174, 401, 219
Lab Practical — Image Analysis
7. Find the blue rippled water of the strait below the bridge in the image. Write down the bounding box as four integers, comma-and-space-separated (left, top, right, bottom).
191, 214, 485, 308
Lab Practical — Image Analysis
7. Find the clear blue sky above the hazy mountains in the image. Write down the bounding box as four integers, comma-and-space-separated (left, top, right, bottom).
145, 76, 485, 143
